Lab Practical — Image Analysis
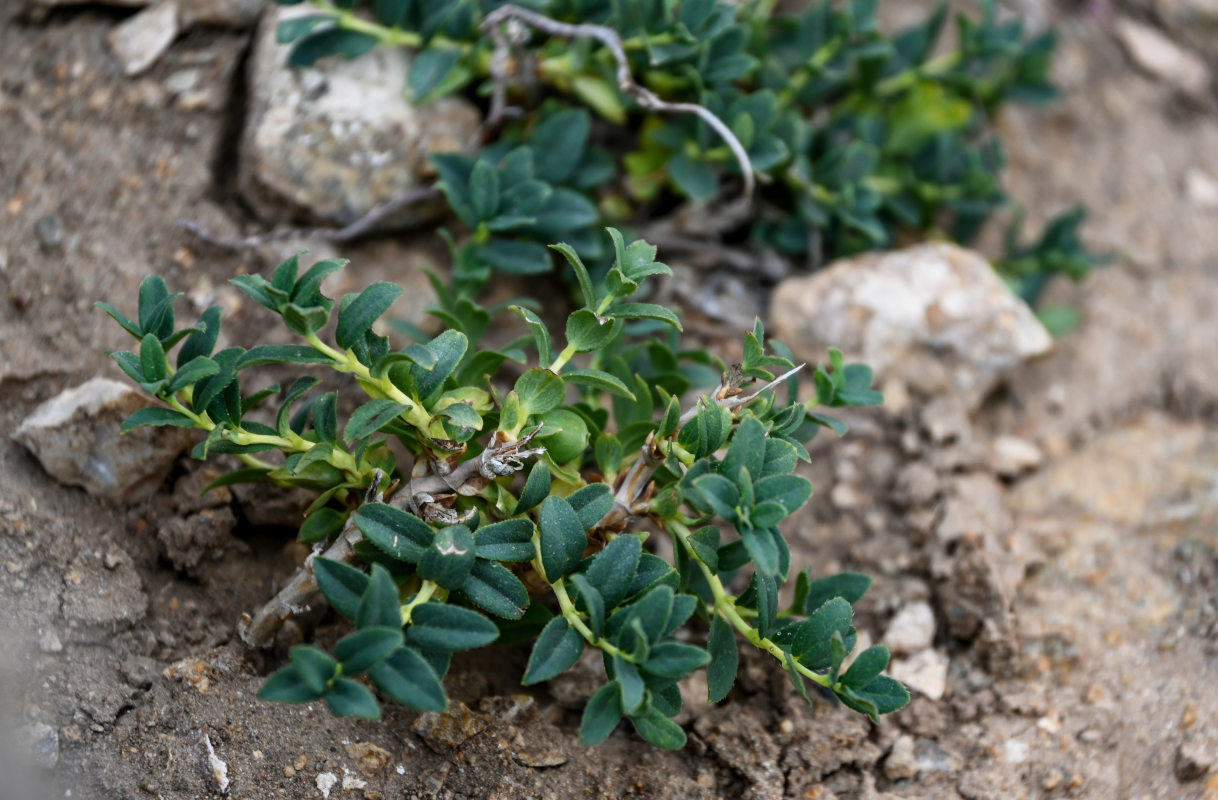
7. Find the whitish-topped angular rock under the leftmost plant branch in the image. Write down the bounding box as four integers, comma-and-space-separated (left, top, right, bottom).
13, 377, 195, 502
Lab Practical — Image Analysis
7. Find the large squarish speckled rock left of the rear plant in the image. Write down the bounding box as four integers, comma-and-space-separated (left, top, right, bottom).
238, 6, 480, 228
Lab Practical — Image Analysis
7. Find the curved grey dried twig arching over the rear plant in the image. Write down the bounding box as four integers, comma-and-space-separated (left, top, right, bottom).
482, 5, 756, 202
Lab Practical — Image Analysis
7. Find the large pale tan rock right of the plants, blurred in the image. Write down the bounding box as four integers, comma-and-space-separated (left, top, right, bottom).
770, 244, 1052, 410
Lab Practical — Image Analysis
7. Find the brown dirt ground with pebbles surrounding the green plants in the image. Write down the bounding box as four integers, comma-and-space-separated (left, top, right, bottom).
0, 0, 1218, 800
